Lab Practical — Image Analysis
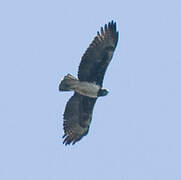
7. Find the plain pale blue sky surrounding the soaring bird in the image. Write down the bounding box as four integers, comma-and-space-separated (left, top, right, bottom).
0, 0, 181, 180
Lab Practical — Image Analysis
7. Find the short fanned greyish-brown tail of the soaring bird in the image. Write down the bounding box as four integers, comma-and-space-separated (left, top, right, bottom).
59, 74, 79, 91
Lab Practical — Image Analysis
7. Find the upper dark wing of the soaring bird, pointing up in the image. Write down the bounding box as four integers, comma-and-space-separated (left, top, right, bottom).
78, 21, 118, 86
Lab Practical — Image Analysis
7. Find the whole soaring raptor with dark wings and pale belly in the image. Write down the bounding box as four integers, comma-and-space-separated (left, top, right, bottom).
59, 21, 118, 145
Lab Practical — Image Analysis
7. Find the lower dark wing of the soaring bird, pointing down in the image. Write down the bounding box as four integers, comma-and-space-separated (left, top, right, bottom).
63, 93, 96, 145
